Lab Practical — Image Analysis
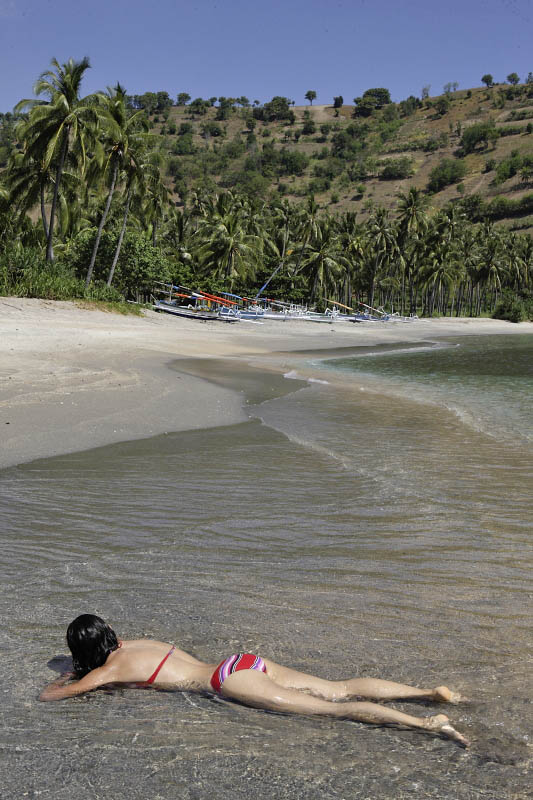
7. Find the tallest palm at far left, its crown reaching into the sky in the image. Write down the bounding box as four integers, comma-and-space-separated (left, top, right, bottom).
16, 58, 96, 261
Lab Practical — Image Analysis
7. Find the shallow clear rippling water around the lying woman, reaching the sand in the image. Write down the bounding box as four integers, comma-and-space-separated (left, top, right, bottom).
0, 336, 533, 800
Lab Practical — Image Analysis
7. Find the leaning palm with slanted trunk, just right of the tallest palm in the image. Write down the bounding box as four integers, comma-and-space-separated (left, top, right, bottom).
85, 83, 147, 286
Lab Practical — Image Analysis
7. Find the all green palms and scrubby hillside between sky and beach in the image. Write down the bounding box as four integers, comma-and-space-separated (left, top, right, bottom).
0, 59, 533, 319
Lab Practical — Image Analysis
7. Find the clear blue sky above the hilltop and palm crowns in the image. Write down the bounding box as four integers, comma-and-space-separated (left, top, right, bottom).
0, 0, 533, 112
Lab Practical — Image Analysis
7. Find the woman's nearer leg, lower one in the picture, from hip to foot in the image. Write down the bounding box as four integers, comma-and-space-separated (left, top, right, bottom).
221, 667, 467, 745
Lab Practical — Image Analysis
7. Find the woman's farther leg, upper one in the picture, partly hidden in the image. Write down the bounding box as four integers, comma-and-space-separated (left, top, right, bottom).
264, 658, 461, 703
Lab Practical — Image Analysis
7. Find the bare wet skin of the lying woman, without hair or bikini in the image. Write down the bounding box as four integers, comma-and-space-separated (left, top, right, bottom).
39, 639, 468, 746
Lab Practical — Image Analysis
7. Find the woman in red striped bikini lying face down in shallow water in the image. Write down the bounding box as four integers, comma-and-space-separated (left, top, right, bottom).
39, 614, 468, 746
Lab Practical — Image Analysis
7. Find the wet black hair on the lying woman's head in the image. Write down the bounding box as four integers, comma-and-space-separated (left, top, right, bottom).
67, 614, 118, 678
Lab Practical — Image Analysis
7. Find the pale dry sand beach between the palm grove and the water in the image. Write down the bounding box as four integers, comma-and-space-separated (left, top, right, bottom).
0, 297, 533, 476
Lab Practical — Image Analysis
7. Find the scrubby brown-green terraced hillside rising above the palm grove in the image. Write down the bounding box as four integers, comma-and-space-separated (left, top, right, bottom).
140, 84, 533, 231
